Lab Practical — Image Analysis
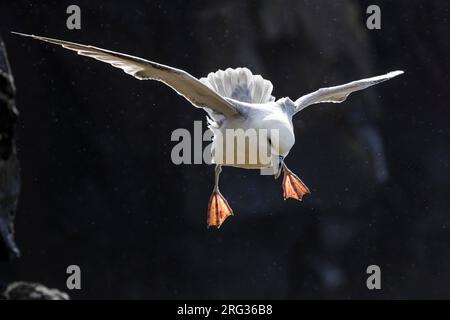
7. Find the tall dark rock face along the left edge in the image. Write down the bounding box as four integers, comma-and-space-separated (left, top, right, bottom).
0, 38, 20, 261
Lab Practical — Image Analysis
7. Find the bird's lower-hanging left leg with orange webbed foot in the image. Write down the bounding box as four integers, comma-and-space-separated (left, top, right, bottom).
207, 165, 233, 228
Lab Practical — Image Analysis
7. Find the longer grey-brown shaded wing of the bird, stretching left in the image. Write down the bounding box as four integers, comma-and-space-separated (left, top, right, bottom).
13, 32, 238, 116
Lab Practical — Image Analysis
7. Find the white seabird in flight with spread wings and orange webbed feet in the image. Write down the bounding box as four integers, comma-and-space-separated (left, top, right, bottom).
13, 32, 403, 228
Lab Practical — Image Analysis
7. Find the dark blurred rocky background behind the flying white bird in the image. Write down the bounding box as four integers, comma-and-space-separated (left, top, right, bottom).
0, 0, 450, 299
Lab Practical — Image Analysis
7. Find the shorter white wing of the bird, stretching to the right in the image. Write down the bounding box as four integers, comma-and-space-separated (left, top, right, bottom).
294, 71, 403, 114
